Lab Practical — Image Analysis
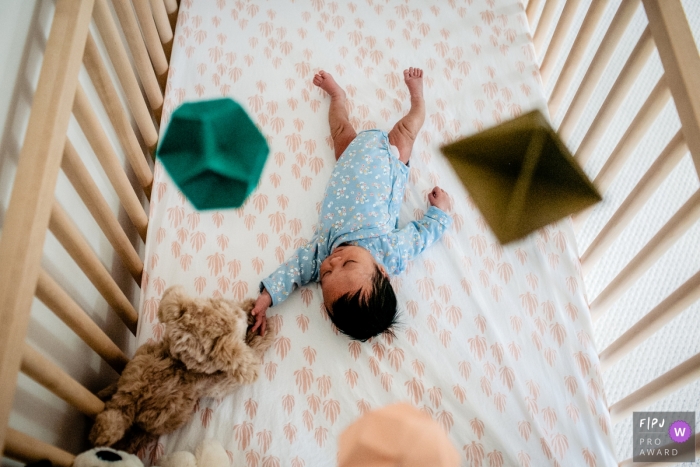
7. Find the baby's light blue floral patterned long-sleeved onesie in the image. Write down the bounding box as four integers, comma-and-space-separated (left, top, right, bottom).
261, 130, 452, 305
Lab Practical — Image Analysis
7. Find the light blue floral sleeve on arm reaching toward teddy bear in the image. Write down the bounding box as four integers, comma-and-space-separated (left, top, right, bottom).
260, 236, 321, 306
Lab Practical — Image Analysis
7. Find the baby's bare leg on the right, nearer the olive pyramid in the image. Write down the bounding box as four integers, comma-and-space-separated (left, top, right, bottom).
389, 68, 425, 164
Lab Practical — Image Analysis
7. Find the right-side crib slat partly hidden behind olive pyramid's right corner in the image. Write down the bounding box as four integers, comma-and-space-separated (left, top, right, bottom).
574, 76, 671, 231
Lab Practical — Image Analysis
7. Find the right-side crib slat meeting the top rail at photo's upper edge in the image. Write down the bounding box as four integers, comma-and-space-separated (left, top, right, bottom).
559, 0, 640, 141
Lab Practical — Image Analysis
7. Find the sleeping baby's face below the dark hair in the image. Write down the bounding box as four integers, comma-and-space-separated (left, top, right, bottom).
319, 245, 377, 310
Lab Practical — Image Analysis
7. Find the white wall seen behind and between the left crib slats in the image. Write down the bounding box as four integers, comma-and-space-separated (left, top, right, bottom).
0, 0, 147, 466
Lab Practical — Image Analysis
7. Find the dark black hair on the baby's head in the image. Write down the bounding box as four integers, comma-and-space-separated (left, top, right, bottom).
328, 265, 397, 342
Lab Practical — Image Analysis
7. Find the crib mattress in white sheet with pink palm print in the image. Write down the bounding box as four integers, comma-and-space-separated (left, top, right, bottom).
138, 0, 615, 467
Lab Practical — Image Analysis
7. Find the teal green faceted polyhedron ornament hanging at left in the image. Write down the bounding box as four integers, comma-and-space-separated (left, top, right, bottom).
157, 98, 270, 210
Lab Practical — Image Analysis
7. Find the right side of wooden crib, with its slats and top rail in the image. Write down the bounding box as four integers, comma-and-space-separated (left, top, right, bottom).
527, 0, 700, 454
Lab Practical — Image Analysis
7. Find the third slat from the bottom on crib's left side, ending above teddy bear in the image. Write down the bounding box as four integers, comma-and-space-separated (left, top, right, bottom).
36, 269, 129, 373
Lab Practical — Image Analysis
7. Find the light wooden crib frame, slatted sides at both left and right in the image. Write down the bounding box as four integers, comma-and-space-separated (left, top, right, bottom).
0, 0, 700, 466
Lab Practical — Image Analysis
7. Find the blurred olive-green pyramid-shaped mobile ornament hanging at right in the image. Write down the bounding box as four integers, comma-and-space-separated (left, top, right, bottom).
440, 110, 602, 244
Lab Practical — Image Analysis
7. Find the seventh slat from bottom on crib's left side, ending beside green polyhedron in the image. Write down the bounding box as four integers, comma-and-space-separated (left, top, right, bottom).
83, 34, 153, 199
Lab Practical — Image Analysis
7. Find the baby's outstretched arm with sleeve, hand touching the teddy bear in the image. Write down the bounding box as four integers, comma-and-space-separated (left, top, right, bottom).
252, 238, 318, 335
